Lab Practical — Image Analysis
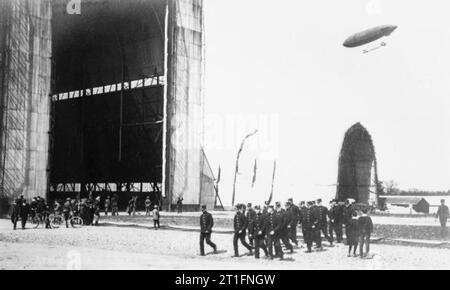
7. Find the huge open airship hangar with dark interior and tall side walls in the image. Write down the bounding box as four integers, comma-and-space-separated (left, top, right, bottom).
0, 0, 215, 213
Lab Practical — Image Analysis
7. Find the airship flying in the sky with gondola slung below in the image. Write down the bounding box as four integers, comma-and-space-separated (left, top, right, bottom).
343, 25, 397, 53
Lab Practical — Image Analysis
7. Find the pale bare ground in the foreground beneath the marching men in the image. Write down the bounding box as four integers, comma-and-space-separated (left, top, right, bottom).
0, 220, 450, 270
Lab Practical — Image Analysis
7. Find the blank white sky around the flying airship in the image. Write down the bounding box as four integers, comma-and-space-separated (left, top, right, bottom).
204, 0, 450, 204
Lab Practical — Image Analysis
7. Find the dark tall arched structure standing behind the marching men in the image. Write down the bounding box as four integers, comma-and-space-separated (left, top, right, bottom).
336, 123, 378, 204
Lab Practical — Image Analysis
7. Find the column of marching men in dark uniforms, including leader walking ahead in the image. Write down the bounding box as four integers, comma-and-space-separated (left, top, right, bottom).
200, 198, 373, 259
